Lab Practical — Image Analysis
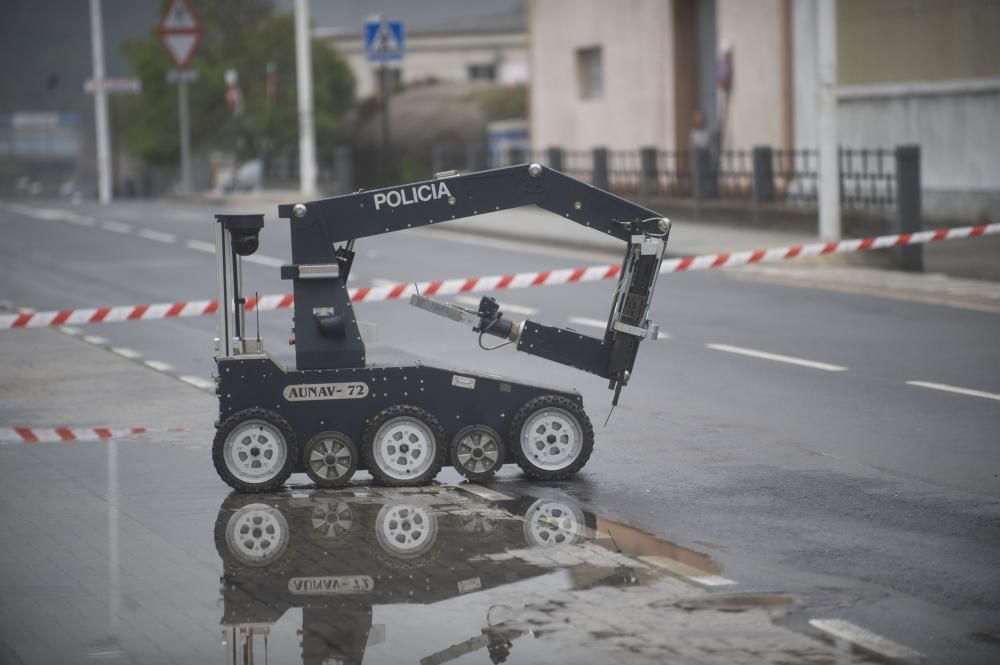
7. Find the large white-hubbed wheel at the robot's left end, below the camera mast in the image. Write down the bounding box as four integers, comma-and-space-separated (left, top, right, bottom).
212, 408, 297, 492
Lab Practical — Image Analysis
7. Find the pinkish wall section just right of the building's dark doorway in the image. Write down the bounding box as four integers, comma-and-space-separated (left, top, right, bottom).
716, 0, 791, 149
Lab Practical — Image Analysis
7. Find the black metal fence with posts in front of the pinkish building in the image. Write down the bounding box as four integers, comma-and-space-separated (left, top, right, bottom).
424, 145, 908, 210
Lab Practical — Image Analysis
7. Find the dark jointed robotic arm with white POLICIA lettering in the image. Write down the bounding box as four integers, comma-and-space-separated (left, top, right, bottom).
278, 164, 670, 404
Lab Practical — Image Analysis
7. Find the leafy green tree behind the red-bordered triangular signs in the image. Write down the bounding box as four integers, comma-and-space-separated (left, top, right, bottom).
116, 0, 354, 165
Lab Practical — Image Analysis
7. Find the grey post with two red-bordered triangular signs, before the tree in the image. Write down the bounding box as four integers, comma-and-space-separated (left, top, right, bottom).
159, 0, 201, 194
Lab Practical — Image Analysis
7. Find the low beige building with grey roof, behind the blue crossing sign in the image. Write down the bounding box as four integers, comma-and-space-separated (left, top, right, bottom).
313, 11, 528, 97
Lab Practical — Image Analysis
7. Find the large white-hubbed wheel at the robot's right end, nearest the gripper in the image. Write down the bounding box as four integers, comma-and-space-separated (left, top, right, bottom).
510, 395, 594, 480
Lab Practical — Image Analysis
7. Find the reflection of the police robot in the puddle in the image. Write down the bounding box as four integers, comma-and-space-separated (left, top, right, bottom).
215, 482, 595, 665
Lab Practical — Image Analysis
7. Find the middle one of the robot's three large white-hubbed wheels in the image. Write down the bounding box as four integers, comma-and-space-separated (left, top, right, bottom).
363, 404, 445, 486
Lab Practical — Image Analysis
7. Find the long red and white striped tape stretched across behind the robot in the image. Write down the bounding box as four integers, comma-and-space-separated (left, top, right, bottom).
0, 224, 1000, 330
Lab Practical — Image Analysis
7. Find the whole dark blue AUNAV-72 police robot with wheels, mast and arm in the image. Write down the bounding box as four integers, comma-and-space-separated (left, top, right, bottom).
212, 163, 670, 492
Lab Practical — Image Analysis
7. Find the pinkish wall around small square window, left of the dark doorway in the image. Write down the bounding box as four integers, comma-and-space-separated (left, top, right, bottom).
526, 0, 686, 150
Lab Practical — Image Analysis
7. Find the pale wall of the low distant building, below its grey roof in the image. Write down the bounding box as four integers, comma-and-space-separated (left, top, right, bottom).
330, 32, 528, 98
